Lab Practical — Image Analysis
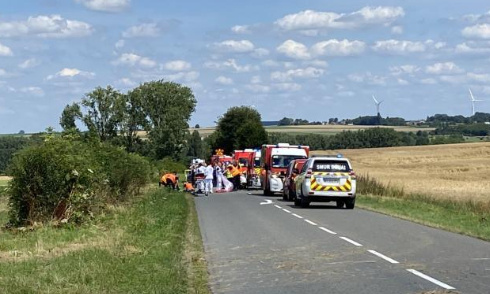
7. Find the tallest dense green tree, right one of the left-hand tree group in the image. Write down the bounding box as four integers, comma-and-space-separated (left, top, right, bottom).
133, 80, 196, 159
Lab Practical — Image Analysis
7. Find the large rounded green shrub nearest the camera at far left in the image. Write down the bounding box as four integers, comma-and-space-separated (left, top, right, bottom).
9, 138, 104, 225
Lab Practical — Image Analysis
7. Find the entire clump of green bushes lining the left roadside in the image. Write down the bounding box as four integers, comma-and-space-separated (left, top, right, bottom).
9, 137, 150, 225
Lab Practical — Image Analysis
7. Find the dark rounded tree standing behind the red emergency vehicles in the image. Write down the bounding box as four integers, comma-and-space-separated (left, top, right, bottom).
212, 106, 267, 153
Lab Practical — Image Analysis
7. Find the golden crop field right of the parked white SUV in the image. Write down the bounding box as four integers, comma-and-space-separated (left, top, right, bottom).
313, 143, 490, 204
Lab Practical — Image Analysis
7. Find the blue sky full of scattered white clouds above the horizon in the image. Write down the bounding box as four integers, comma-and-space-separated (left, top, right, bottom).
0, 0, 490, 133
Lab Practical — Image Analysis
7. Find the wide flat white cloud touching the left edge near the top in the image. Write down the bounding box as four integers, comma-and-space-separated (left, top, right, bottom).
0, 15, 93, 38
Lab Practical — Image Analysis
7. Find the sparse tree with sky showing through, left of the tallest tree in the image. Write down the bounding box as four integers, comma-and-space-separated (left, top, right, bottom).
82, 86, 123, 141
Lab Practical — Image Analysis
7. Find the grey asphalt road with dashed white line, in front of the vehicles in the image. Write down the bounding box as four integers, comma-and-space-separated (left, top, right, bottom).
195, 191, 490, 294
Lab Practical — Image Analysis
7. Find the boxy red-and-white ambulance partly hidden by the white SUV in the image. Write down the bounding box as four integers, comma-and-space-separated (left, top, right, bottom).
260, 143, 310, 195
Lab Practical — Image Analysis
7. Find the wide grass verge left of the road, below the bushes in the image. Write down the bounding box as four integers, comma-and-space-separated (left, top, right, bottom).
0, 189, 209, 293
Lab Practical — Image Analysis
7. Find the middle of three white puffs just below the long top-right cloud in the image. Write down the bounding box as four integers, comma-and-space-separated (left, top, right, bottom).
311, 39, 366, 56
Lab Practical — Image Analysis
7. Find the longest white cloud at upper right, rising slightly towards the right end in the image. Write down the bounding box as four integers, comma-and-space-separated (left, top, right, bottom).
274, 6, 405, 31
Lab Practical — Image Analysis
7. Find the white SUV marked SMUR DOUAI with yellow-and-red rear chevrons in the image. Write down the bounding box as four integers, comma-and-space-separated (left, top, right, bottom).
294, 155, 356, 209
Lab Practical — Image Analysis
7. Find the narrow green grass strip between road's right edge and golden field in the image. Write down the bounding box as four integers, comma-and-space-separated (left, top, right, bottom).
356, 195, 490, 241
